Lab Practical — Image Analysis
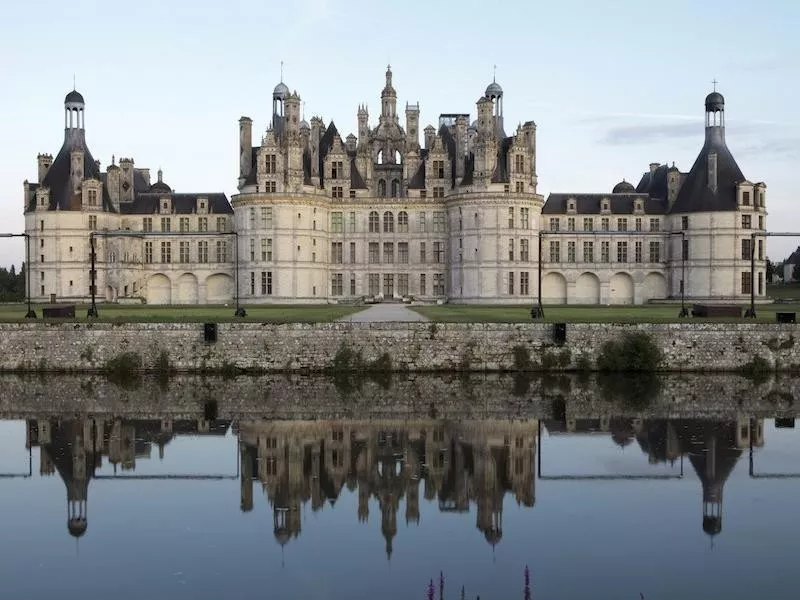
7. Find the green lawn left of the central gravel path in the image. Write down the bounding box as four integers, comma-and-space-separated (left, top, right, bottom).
0, 304, 364, 323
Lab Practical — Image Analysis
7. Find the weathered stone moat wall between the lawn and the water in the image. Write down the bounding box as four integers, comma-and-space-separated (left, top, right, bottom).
0, 323, 800, 372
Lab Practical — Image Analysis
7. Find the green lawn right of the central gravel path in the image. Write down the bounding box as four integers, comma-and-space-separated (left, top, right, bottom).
411, 303, 800, 323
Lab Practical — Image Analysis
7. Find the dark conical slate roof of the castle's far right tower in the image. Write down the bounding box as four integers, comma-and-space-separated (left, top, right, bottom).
671, 127, 745, 213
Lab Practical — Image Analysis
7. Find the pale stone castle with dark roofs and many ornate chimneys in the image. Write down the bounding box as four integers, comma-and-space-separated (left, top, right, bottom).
24, 68, 766, 304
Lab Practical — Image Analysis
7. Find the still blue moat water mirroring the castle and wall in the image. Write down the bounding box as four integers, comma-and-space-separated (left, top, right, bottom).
0, 378, 800, 600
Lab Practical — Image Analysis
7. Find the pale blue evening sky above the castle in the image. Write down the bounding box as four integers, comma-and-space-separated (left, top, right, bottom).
0, 0, 800, 266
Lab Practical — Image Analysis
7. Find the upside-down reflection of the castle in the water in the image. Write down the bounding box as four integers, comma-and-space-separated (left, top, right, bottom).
20, 416, 780, 557
